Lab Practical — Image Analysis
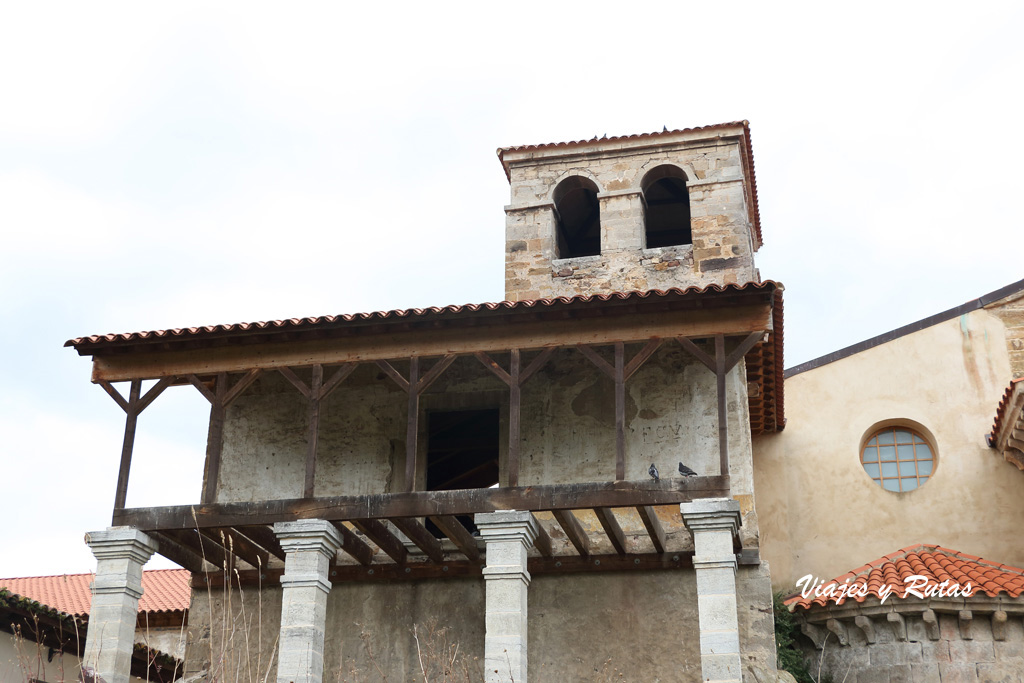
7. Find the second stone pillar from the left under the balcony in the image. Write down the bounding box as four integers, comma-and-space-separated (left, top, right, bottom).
273, 519, 342, 683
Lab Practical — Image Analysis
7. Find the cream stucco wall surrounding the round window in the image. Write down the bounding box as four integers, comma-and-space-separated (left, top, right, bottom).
755, 310, 1024, 590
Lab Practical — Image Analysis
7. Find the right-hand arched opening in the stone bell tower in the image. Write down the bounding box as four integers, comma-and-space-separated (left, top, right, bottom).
641, 166, 693, 249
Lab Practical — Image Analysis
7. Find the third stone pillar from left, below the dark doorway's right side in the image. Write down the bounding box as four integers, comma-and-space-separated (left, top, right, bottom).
474, 510, 538, 683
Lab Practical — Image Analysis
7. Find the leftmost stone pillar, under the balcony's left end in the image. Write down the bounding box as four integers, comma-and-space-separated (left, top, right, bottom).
82, 526, 157, 683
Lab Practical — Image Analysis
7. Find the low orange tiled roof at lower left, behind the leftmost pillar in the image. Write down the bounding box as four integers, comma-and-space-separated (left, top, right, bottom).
0, 569, 191, 616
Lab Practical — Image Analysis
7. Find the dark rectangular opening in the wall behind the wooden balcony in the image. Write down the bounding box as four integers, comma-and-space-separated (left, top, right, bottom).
427, 408, 501, 539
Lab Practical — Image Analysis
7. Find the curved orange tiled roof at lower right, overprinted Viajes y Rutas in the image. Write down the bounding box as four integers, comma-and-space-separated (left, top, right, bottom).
785, 544, 1024, 609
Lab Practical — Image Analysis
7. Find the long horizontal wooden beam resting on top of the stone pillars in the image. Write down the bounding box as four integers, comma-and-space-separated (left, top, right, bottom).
114, 476, 729, 531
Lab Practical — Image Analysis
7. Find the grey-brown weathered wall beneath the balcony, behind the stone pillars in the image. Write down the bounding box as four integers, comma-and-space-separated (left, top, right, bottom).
187, 567, 775, 683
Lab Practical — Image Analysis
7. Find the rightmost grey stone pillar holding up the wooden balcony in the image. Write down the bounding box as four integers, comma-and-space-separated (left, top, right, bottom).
680, 498, 742, 683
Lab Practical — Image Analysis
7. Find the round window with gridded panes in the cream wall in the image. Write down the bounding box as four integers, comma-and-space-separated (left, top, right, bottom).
860, 427, 935, 492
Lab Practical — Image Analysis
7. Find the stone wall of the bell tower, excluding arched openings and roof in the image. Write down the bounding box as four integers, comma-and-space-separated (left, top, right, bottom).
505, 139, 758, 301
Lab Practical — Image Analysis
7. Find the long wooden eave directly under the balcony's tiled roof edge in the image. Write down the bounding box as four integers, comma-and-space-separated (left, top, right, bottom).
91, 290, 774, 382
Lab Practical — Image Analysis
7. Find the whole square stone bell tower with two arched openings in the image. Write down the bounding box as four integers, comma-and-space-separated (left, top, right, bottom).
498, 121, 761, 301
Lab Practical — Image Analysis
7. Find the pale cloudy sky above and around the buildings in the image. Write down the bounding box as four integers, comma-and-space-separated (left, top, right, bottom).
0, 0, 1024, 577
